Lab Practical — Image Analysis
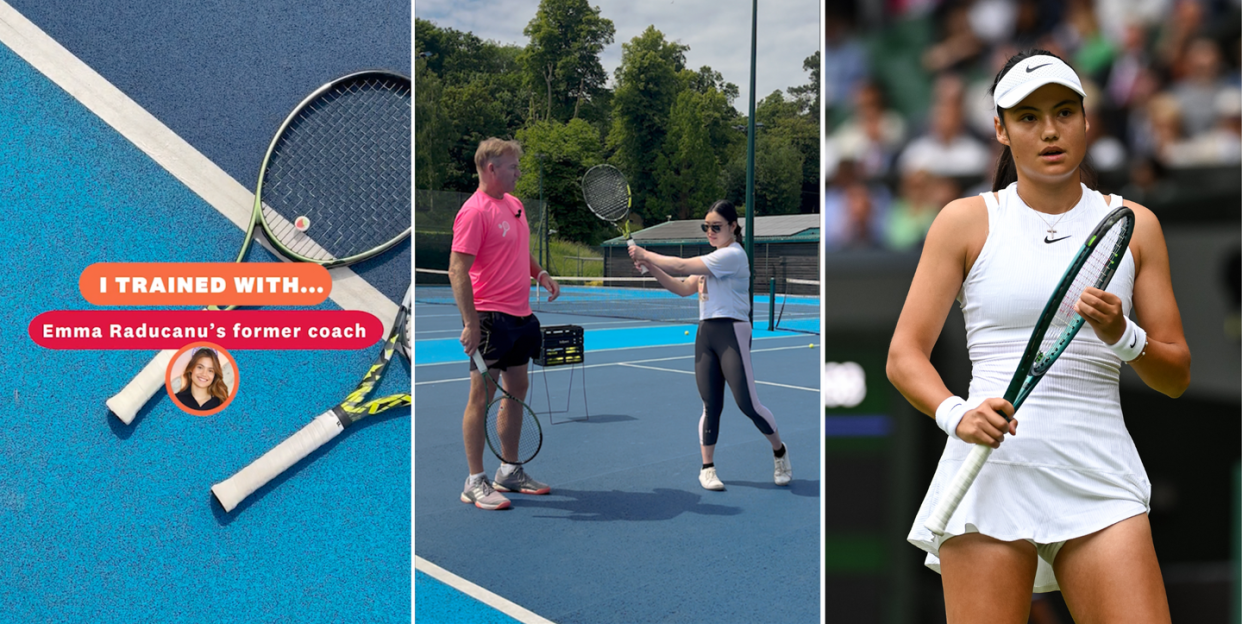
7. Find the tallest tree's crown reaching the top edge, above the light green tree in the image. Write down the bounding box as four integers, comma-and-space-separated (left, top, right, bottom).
520, 0, 616, 121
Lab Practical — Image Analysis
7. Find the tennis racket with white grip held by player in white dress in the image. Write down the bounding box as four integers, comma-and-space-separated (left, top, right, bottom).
924, 208, 1134, 535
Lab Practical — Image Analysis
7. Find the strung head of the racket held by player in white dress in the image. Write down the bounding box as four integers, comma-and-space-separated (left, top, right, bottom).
1005, 206, 1134, 408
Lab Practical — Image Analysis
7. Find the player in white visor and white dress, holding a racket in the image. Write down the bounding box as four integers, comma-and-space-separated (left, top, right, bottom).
888, 50, 1190, 624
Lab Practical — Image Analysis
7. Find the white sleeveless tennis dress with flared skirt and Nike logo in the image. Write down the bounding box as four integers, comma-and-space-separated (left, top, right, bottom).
907, 183, 1151, 592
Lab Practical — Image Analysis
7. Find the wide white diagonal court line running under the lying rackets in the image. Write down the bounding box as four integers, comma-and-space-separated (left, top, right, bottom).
0, 0, 397, 325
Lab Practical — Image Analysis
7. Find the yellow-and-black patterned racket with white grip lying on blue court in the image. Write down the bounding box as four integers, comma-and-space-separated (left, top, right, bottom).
211, 286, 412, 511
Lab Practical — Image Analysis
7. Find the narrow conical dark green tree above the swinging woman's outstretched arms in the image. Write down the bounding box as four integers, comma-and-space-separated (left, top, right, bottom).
648, 88, 720, 219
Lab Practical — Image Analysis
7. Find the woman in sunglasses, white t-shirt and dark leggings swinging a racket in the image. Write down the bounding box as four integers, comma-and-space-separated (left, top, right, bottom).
630, 200, 794, 490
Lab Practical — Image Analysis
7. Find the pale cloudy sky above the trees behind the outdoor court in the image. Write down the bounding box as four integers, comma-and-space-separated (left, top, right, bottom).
414, 0, 823, 114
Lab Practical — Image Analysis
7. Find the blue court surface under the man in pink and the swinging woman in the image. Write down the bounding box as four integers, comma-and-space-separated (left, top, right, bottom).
415, 305, 822, 624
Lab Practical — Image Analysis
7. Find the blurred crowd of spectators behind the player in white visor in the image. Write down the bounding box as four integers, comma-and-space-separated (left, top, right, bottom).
823, 0, 1242, 251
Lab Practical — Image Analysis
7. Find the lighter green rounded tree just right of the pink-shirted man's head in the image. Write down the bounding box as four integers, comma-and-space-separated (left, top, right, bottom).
517, 119, 606, 245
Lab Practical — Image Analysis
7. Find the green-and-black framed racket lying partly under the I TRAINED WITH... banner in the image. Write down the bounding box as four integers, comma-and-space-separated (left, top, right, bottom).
107, 71, 411, 425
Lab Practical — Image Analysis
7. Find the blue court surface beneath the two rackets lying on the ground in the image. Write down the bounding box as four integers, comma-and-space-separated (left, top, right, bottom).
0, 0, 412, 623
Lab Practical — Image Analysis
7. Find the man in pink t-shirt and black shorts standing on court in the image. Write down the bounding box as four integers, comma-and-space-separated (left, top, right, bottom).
448, 138, 560, 510
